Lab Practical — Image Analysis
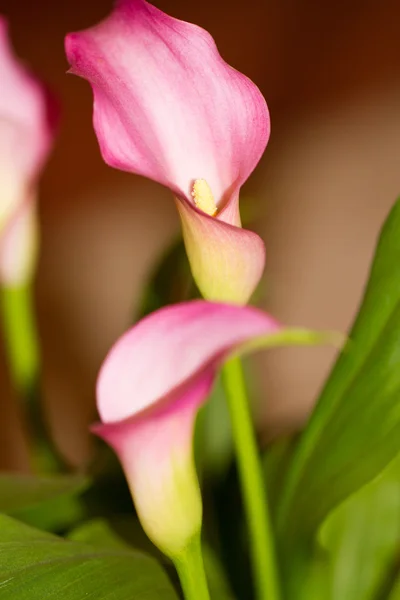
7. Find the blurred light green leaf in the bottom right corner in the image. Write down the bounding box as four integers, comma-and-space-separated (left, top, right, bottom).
320, 459, 400, 600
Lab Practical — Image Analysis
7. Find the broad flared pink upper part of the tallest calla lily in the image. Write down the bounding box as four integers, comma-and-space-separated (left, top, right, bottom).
66, 0, 270, 206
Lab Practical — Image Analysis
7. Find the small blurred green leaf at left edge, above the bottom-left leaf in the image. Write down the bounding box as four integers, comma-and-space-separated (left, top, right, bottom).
0, 473, 90, 531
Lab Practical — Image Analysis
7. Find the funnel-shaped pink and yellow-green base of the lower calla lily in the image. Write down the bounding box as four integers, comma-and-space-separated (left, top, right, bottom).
92, 369, 214, 557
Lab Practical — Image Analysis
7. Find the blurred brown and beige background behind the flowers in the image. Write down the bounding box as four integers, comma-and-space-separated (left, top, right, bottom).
0, 0, 400, 466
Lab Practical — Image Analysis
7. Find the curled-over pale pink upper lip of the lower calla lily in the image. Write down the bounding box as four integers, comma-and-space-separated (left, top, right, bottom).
97, 300, 280, 423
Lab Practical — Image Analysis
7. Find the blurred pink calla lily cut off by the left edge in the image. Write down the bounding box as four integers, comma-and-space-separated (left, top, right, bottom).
0, 16, 54, 285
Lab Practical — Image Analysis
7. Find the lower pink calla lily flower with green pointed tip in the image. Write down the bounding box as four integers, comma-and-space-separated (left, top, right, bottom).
92, 300, 321, 558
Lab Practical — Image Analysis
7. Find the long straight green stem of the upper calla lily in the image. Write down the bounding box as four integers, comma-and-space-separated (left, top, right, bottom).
222, 357, 281, 600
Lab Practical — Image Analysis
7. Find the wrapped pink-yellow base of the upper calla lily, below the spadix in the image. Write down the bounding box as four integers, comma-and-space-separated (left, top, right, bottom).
176, 199, 265, 304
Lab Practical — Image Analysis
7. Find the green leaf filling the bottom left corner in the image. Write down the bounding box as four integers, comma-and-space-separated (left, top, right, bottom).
0, 516, 177, 600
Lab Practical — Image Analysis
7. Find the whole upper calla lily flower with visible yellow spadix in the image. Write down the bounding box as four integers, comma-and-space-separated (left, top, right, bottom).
66, 0, 270, 303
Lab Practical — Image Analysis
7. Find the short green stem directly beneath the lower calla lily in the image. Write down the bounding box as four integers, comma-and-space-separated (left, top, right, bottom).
174, 535, 210, 600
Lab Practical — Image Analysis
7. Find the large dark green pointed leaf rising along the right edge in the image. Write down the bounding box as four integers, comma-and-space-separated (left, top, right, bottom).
278, 201, 400, 547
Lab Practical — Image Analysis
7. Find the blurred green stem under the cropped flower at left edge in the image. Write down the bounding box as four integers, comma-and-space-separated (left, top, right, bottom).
1, 284, 60, 471
